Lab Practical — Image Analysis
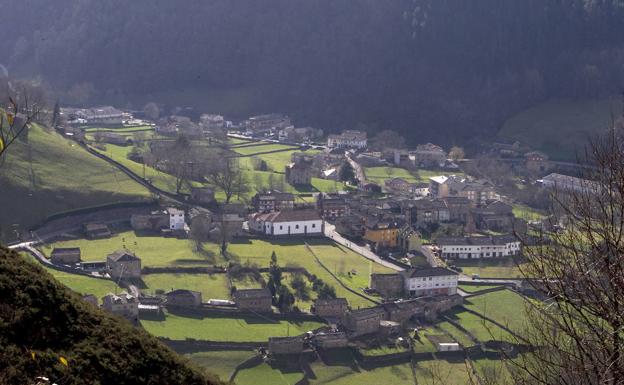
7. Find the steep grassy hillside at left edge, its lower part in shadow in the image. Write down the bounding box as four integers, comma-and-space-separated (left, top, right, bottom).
0, 126, 149, 236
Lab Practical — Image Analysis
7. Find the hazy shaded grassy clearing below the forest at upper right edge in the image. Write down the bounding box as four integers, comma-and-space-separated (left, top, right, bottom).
498, 99, 621, 160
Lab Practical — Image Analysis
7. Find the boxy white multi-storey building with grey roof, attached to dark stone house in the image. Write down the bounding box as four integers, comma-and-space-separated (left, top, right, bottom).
402, 267, 458, 297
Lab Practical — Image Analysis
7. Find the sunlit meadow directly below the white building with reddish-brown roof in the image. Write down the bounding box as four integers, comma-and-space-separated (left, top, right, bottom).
228, 239, 391, 308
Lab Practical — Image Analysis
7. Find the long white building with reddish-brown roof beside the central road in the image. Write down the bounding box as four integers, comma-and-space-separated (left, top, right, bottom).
249, 210, 323, 236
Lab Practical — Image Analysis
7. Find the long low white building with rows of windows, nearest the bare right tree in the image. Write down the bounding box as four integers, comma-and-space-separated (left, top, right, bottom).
436, 235, 521, 259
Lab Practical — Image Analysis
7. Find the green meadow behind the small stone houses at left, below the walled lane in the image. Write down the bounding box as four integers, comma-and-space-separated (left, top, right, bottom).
43, 231, 225, 267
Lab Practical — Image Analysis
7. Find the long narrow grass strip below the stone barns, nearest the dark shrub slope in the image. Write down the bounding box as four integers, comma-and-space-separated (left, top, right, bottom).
141, 313, 323, 342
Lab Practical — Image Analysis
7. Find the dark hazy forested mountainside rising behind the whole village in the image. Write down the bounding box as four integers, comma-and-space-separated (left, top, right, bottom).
0, 0, 624, 144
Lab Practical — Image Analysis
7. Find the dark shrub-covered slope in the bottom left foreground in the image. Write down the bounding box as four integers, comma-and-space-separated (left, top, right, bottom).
0, 248, 219, 385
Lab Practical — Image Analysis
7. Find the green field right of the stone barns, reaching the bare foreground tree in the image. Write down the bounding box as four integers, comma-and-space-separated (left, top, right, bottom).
464, 290, 526, 331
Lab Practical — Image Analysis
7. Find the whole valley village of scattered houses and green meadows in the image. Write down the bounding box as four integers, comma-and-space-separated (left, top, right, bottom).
12, 103, 589, 382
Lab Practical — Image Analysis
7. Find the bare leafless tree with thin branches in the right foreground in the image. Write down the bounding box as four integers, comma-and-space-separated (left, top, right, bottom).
511, 124, 624, 384
